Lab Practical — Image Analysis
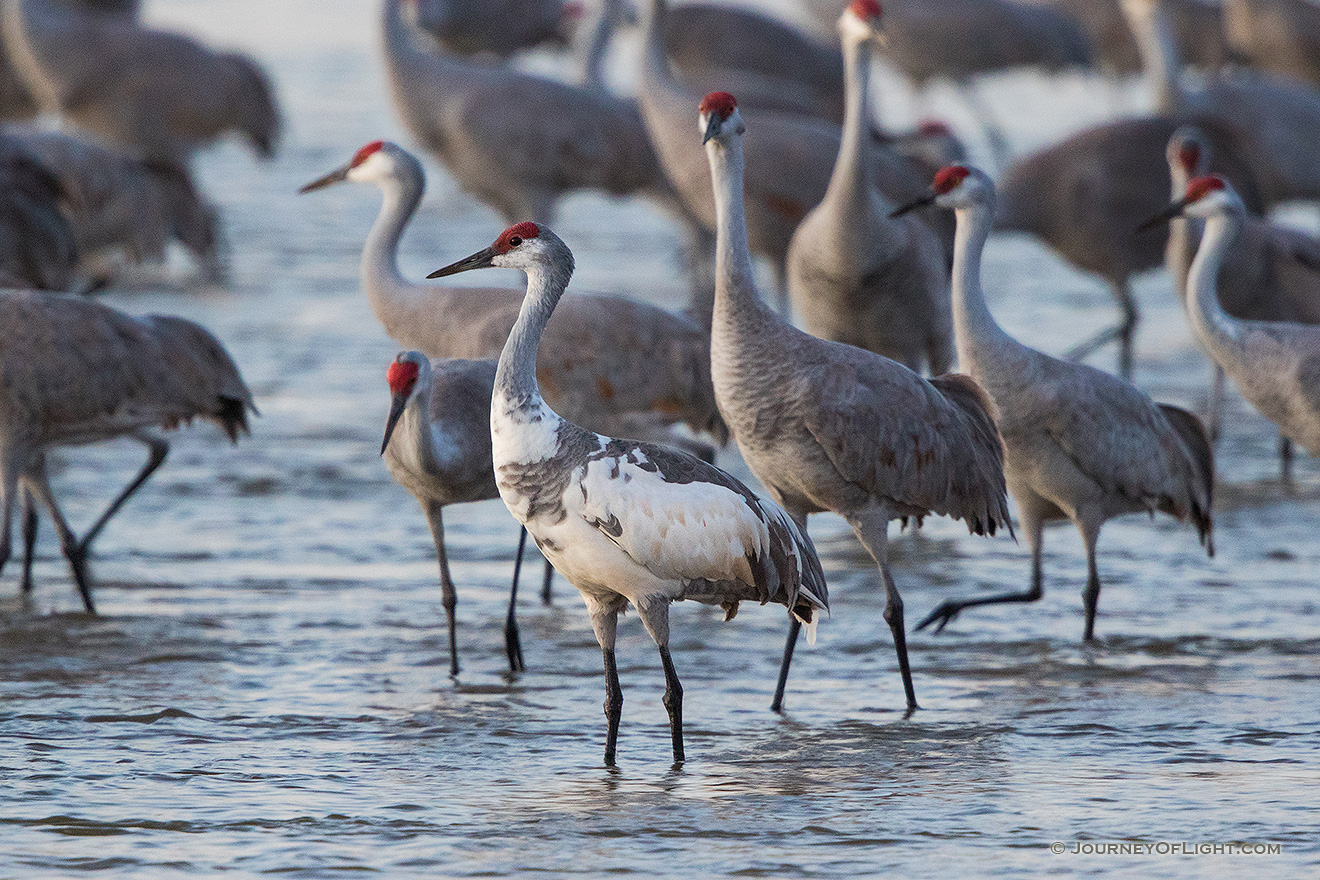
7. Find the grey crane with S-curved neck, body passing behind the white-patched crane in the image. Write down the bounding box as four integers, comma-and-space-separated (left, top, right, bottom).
304, 141, 727, 443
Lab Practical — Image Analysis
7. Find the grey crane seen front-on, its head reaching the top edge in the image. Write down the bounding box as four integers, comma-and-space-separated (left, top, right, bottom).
781, 0, 953, 376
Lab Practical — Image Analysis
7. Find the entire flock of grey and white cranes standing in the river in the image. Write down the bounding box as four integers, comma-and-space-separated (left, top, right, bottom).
0, 0, 1320, 764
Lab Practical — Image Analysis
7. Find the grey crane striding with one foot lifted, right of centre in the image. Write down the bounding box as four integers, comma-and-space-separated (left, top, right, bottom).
900, 165, 1214, 641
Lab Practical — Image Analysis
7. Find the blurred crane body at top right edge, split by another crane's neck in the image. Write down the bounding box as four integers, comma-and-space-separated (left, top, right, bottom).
1034, 0, 1232, 75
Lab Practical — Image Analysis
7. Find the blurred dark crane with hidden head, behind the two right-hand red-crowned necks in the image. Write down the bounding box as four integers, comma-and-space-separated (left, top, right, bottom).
994, 116, 1266, 377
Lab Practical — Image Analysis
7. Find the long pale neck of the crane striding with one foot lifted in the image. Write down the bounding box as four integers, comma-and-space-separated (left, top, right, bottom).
953, 198, 1022, 375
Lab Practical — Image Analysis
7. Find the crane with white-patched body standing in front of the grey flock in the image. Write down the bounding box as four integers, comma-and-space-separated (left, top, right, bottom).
428, 223, 829, 765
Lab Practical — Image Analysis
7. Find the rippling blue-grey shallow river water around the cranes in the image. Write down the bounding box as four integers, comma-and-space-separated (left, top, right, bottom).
0, 0, 1320, 879
